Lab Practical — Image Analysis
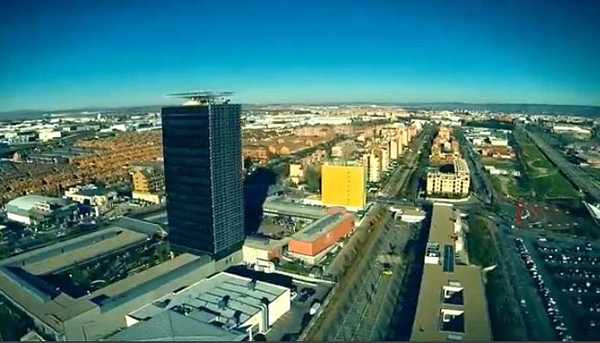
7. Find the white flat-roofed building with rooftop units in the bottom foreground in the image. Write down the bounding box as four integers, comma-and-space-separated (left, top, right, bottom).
109, 273, 291, 341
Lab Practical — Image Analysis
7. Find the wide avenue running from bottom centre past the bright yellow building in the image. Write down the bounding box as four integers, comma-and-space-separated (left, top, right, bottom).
303, 126, 433, 341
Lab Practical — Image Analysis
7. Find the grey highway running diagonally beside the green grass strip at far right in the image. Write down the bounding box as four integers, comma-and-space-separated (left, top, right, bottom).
515, 126, 600, 202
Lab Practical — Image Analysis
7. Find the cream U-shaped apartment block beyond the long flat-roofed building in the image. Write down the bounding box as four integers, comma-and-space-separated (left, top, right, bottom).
427, 158, 471, 197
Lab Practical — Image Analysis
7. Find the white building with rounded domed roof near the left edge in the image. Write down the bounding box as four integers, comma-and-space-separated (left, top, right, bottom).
5, 195, 78, 225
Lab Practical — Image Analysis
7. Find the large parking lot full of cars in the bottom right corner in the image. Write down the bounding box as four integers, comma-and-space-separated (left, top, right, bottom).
514, 232, 600, 341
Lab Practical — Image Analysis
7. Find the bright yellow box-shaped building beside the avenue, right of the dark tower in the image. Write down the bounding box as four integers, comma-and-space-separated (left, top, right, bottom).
321, 164, 367, 211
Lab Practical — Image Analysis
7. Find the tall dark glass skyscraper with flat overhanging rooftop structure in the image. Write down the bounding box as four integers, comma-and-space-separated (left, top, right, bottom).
162, 92, 244, 259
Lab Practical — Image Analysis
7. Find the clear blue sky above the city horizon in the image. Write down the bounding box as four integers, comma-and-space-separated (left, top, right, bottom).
0, 0, 600, 111
